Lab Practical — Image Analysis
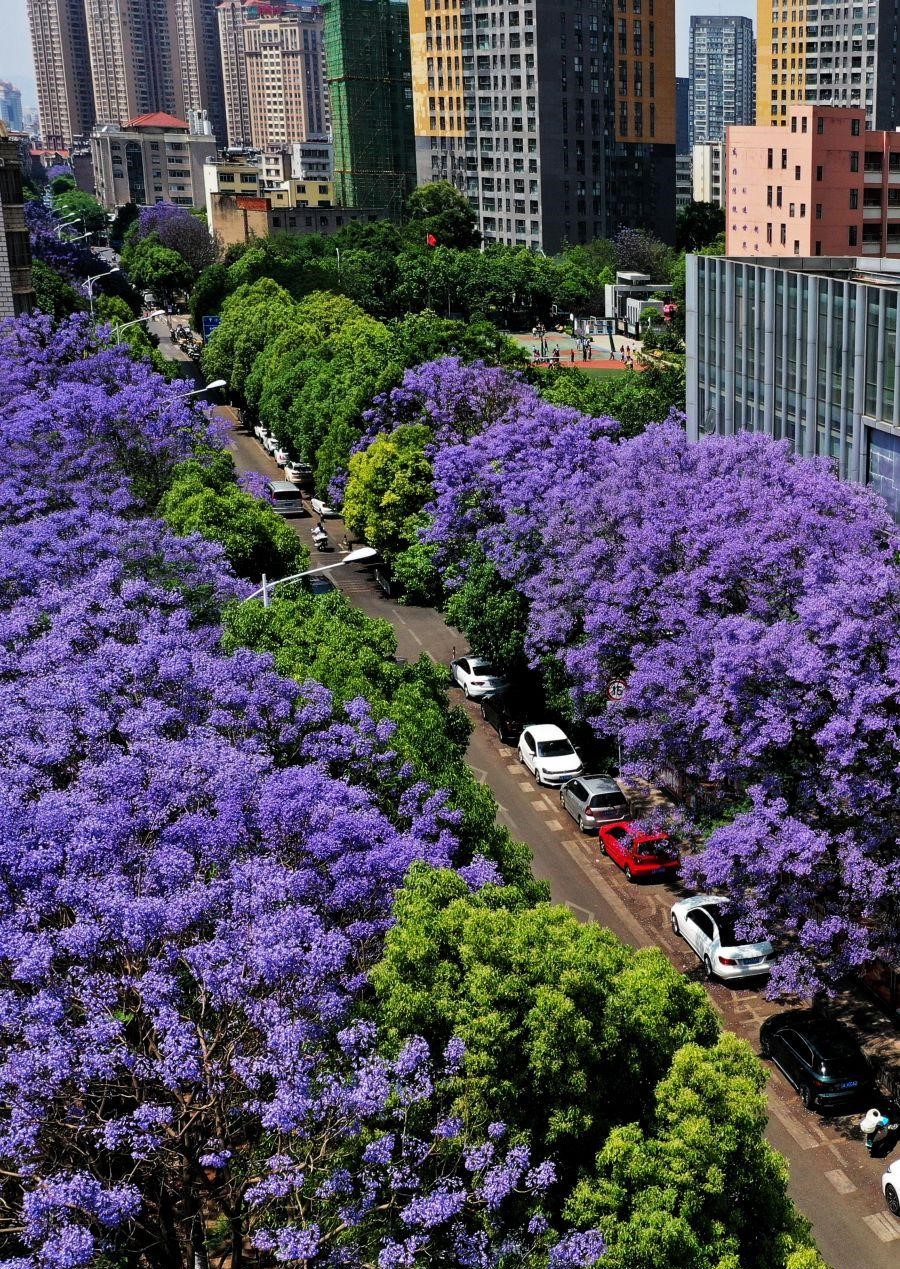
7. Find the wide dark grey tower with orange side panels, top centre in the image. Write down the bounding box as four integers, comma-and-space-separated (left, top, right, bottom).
410, 0, 675, 251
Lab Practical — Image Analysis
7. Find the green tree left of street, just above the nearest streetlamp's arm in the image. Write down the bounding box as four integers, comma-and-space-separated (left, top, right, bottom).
159, 456, 310, 581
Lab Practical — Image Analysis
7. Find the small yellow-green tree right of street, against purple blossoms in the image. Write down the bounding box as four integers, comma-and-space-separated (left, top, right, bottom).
344, 424, 433, 558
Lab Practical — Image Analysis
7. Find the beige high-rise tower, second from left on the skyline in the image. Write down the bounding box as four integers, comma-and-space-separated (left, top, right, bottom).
83, 0, 225, 133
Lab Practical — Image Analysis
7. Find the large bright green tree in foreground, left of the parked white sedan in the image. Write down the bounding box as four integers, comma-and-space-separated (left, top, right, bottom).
372, 867, 718, 1172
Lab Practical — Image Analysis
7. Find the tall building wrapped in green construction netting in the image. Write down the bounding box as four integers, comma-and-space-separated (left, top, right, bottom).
322, 0, 415, 218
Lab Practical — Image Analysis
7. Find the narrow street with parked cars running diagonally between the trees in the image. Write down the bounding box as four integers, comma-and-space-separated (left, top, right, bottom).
211, 388, 900, 1269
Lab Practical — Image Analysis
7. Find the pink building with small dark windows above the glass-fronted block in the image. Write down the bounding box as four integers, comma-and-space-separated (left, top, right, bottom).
725, 104, 900, 256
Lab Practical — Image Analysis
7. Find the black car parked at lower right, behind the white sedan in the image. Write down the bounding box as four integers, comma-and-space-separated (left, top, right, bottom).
759, 1009, 872, 1110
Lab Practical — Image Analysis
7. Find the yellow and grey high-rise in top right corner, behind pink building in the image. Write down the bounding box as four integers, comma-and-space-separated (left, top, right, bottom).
757, 0, 900, 129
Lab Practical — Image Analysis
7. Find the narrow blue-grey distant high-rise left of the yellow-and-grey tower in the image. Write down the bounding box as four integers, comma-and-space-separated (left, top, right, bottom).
688, 14, 757, 146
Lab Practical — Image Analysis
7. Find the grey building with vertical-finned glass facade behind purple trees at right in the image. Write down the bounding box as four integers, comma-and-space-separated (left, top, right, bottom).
687, 256, 900, 520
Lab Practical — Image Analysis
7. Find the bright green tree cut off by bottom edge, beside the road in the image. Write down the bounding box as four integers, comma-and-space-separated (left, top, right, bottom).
566, 1033, 825, 1269
